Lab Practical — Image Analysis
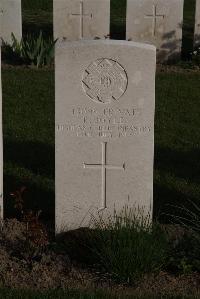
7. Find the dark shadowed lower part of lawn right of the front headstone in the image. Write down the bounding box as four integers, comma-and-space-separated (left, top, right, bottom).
154, 147, 200, 223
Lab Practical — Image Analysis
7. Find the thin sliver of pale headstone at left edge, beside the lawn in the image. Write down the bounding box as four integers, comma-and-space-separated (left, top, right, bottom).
0, 43, 3, 220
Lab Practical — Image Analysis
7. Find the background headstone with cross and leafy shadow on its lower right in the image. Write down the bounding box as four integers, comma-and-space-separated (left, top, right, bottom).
126, 0, 183, 62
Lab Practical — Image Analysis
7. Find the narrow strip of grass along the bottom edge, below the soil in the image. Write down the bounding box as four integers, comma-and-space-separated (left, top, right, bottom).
0, 289, 200, 299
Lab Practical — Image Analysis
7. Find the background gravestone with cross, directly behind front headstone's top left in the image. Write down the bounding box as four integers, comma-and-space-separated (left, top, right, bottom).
54, 0, 110, 40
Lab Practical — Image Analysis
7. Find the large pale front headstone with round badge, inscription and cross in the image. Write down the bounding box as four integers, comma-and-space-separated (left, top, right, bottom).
55, 40, 156, 232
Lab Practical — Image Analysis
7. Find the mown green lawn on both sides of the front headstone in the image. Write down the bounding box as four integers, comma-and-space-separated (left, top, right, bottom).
3, 68, 200, 221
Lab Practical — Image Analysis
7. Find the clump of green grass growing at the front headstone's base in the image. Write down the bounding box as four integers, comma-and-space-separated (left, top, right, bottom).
88, 206, 167, 284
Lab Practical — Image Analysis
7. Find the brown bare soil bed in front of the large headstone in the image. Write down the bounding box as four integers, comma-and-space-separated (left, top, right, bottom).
0, 219, 200, 296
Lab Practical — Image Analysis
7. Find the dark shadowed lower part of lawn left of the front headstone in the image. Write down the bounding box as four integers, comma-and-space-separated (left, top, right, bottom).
4, 140, 55, 225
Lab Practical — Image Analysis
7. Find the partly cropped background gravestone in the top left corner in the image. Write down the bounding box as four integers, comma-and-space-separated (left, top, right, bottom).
0, 0, 22, 43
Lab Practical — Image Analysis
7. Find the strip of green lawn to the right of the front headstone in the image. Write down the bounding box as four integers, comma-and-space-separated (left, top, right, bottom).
154, 73, 200, 220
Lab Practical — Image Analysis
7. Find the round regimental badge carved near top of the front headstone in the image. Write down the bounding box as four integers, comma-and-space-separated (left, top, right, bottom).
82, 58, 128, 104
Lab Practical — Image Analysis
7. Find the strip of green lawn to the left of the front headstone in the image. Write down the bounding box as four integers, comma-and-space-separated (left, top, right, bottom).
3, 68, 54, 219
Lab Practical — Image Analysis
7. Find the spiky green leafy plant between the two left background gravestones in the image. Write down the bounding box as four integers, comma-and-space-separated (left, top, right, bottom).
3, 31, 57, 68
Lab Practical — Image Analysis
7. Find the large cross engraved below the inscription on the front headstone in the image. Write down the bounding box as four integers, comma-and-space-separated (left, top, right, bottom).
83, 142, 125, 211
